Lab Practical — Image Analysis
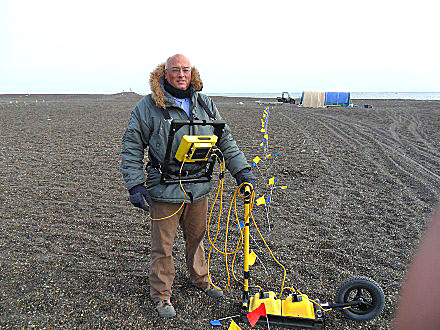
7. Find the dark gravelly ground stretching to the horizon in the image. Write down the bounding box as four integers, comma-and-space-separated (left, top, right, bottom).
0, 93, 440, 329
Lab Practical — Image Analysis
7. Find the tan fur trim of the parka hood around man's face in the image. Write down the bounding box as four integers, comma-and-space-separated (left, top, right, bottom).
150, 63, 203, 109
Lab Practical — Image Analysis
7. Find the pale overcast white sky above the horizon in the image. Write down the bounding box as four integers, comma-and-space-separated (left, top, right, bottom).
0, 0, 440, 94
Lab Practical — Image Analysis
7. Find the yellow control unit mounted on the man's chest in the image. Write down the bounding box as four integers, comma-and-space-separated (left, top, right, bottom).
176, 135, 218, 163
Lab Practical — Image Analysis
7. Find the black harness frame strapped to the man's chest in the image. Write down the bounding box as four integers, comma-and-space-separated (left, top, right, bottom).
146, 94, 225, 184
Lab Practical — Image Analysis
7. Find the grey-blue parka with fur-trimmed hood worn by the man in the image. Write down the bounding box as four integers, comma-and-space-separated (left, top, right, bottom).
120, 64, 250, 203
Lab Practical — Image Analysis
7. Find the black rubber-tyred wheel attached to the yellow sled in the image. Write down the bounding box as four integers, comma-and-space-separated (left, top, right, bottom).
336, 276, 385, 321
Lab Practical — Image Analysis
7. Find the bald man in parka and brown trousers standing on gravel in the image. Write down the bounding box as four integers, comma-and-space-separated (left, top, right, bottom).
120, 54, 255, 317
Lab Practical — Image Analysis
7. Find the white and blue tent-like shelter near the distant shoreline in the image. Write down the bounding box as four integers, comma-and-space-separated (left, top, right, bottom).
301, 91, 350, 108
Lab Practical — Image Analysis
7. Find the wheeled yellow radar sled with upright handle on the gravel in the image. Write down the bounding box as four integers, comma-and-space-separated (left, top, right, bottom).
241, 187, 385, 330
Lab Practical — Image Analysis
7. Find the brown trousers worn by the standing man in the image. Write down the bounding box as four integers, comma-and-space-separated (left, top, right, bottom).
150, 198, 209, 302
